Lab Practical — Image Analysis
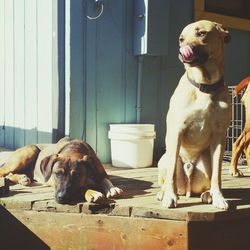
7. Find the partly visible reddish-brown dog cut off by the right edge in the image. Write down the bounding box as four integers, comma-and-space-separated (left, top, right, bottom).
230, 76, 250, 177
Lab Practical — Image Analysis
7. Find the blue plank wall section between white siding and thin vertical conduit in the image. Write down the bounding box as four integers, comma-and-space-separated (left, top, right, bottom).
70, 0, 137, 162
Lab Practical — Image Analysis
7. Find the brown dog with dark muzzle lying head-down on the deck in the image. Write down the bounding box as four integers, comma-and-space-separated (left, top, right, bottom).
0, 138, 123, 204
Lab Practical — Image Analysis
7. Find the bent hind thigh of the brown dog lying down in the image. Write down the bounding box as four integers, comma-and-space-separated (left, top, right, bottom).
0, 145, 40, 177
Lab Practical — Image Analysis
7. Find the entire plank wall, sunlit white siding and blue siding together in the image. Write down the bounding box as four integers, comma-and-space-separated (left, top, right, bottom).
0, 0, 250, 162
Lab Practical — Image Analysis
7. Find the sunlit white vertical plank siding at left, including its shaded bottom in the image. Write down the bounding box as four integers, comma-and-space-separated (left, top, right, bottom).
0, 0, 53, 148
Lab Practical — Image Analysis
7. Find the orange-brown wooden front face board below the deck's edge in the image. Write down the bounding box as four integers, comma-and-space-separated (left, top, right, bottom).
0, 210, 188, 250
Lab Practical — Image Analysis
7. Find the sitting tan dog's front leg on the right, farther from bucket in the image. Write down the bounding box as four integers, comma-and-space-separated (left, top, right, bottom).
210, 134, 228, 210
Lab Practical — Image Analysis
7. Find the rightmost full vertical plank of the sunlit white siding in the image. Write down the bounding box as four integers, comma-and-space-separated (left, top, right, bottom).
37, 0, 52, 142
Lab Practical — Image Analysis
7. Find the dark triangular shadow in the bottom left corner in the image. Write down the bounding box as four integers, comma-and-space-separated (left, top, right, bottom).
0, 206, 50, 250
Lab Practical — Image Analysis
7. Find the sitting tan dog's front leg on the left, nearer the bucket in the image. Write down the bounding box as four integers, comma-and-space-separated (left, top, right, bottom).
162, 130, 182, 208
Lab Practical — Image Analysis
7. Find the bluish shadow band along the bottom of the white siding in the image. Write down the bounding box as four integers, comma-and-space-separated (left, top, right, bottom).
0, 126, 64, 149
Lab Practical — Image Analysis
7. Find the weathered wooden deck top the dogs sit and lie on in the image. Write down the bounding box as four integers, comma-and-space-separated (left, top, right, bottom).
0, 164, 250, 221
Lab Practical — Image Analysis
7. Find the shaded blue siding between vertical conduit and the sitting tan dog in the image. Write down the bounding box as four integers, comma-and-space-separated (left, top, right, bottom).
141, 0, 193, 158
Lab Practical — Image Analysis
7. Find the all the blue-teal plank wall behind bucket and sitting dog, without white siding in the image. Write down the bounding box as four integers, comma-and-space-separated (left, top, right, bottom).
69, 0, 250, 162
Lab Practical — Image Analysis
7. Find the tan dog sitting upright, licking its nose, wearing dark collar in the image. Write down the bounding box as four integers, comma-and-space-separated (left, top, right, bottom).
158, 20, 231, 209
